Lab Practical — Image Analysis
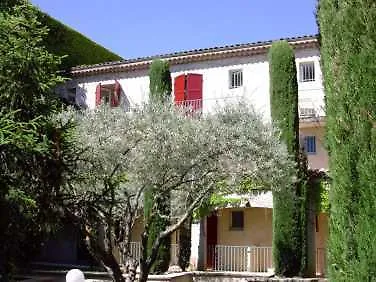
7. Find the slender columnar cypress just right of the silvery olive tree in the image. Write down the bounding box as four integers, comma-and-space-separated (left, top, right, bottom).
269, 41, 306, 277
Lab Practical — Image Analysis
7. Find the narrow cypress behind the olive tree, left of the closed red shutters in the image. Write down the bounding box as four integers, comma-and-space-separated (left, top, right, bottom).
144, 60, 172, 273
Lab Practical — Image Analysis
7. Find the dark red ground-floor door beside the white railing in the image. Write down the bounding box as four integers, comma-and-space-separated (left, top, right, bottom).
206, 214, 218, 269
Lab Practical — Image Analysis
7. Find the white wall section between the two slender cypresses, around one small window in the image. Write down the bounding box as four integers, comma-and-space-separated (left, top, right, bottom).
171, 55, 270, 120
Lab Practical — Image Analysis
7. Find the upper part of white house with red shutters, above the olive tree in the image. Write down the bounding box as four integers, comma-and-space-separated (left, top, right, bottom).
59, 36, 327, 169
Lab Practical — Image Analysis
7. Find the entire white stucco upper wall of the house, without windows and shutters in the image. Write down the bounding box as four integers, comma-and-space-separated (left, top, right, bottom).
60, 49, 324, 121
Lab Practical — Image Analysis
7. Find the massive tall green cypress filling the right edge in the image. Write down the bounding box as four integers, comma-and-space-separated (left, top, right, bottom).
317, 0, 376, 281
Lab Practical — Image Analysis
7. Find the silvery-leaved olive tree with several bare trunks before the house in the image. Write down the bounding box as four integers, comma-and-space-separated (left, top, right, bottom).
61, 105, 294, 281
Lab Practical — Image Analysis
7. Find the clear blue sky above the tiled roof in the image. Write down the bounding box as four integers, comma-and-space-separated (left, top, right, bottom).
31, 0, 317, 58
